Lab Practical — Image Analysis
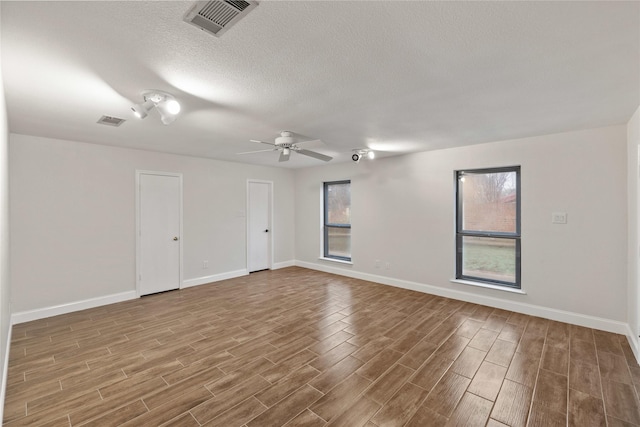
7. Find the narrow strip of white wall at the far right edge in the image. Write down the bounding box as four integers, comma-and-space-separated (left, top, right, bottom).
627, 107, 640, 359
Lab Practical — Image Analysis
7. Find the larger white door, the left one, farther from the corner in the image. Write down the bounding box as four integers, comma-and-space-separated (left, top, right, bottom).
138, 173, 182, 296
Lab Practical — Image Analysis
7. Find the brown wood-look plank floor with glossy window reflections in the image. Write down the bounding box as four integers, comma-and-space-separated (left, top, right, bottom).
4, 267, 640, 427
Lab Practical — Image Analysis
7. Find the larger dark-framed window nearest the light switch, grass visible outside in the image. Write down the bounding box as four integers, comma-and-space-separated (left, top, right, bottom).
456, 166, 520, 289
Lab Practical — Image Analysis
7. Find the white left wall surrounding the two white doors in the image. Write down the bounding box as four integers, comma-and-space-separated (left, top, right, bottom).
10, 134, 294, 313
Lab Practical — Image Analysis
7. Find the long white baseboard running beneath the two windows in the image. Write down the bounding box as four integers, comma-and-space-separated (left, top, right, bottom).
296, 261, 638, 338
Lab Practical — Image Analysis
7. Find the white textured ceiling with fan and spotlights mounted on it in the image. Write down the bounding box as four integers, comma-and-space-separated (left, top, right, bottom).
0, 0, 640, 167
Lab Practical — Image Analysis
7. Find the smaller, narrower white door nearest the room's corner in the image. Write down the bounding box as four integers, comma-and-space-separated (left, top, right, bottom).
247, 181, 272, 273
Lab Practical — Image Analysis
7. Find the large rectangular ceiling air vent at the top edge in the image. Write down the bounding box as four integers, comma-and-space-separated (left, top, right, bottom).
184, 0, 258, 37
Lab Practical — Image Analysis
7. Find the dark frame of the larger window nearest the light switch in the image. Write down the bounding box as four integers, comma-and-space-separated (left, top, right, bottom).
454, 166, 522, 289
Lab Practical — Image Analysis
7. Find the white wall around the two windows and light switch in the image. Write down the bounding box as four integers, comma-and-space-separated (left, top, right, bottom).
295, 126, 627, 329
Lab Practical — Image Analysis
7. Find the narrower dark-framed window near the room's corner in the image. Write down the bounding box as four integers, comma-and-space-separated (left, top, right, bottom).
324, 181, 351, 261
